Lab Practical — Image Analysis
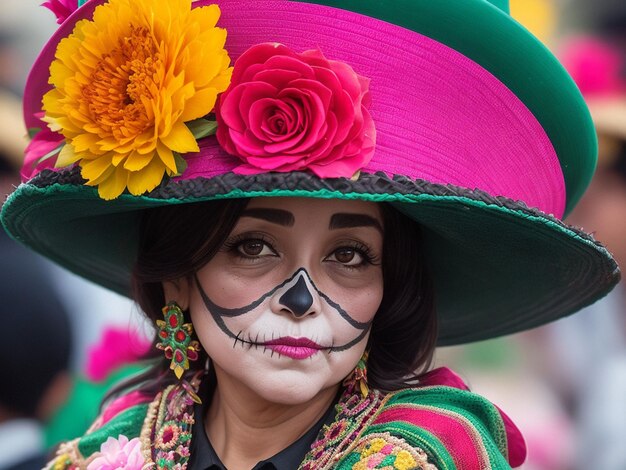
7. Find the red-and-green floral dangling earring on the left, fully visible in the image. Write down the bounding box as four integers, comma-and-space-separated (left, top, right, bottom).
156, 302, 200, 379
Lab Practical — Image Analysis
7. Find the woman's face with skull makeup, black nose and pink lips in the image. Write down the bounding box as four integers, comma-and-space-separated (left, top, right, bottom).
176, 198, 383, 404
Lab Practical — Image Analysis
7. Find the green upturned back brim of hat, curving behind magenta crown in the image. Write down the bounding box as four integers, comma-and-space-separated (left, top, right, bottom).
307, 0, 597, 214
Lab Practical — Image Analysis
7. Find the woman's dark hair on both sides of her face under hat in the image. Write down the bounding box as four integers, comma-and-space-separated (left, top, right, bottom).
132, 199, 437, 391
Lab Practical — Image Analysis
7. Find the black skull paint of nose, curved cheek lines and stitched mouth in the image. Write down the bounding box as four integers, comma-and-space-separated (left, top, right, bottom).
195, 268, 371, 359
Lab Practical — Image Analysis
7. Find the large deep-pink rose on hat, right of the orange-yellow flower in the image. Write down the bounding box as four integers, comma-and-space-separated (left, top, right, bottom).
216, 44, 376, 178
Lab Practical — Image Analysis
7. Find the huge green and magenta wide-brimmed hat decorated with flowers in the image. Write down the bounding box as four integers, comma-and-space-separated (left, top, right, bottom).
2, 0, 619, 345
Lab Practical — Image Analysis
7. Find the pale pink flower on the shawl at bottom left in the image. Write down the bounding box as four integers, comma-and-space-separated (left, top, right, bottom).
87, 435, 145, 470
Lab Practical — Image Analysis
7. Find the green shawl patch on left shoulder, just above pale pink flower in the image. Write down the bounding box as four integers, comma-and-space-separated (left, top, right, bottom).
78, 404, 148, 457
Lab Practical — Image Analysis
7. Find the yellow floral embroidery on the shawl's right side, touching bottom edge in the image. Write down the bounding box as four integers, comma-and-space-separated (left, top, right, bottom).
347, 433, 437, 470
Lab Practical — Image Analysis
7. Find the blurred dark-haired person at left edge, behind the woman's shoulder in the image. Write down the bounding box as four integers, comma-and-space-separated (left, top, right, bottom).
0, 232, 72, 470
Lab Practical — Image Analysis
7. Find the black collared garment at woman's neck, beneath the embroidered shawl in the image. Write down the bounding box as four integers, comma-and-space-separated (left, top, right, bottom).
187, 378, 335, 470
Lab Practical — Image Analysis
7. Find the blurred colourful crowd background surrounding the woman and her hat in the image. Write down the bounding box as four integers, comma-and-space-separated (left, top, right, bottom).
0, 0, 626, 470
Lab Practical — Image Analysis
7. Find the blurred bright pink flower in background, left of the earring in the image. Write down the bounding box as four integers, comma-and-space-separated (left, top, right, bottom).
85, 327, 151, 381
